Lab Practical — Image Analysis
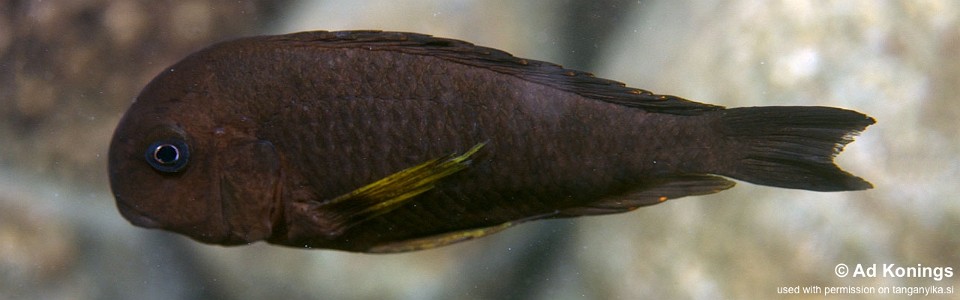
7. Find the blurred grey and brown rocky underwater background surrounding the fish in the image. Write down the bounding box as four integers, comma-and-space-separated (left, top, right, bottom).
0, 0, 960, 299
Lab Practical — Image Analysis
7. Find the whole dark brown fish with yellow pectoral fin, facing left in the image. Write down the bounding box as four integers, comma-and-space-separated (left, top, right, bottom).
109, 31, 874, 252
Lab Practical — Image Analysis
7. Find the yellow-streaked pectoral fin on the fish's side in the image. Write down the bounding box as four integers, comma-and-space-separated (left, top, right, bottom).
320, 143, 485, 235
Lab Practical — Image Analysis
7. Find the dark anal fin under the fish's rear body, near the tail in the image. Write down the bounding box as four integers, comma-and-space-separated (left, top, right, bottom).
556, 174, 735, 217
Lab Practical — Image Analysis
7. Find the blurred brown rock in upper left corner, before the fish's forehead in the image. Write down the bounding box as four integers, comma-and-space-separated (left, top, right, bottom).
0, 0, 285, 186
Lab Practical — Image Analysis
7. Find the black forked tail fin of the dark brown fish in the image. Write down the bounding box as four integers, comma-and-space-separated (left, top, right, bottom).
717, 106, 875, 191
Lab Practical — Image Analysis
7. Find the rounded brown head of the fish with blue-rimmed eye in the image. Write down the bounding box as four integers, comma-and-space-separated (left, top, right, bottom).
108, 50, 281, 245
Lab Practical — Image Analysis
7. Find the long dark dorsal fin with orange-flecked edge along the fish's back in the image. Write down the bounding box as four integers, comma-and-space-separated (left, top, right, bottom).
271, 31, 723, 115
